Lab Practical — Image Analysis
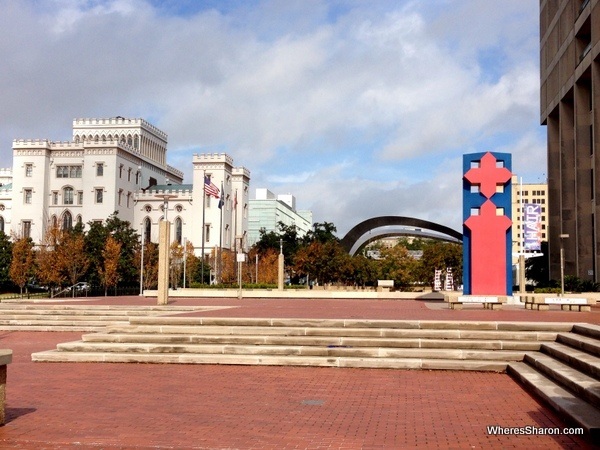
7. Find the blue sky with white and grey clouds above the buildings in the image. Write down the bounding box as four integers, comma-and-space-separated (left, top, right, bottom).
0, 0, 546, 237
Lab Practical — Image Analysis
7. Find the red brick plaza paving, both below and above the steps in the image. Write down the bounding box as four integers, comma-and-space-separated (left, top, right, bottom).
0, 297, 600, 449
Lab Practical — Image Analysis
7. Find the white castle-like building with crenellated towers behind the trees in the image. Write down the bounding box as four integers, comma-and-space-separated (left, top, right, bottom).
0, 117, 250, 255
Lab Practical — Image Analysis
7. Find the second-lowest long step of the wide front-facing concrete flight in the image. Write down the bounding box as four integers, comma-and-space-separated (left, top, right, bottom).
57, 341, 524, 361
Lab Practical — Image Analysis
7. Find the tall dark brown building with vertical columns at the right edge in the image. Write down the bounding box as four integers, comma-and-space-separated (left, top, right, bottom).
540, 0, 600, 282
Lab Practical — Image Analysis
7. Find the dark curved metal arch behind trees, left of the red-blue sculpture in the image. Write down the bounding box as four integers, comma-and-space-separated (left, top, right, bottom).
340, 216, 463, 255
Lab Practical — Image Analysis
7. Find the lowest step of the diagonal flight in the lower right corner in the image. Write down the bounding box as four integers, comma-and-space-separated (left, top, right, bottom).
507, 362, 600, 444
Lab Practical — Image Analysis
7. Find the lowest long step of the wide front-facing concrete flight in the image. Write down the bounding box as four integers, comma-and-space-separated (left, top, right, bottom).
32, 350, 507, 372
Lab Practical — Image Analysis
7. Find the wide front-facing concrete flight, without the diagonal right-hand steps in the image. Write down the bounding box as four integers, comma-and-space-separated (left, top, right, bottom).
32, 316, 572, 372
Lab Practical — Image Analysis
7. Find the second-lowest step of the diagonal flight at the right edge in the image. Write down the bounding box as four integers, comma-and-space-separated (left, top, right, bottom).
524, 352, 600, 406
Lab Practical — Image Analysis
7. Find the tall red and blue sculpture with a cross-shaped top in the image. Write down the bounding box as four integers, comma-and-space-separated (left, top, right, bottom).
463, 152, 512, 295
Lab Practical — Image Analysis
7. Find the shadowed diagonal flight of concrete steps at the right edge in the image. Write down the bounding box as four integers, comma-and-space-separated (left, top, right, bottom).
507, 324, 600, 443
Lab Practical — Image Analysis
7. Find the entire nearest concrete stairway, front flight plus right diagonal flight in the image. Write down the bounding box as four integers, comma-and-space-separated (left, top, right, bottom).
32, 310, 600, 441
